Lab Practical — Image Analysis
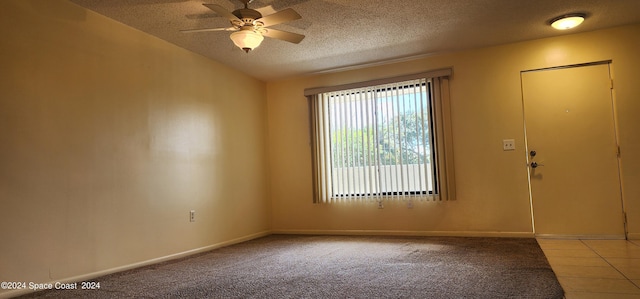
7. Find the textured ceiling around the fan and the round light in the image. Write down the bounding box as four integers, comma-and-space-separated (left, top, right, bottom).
71, 0, 640, 81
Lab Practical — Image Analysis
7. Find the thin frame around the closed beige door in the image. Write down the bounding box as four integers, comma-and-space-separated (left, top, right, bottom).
520, 60, 629, 239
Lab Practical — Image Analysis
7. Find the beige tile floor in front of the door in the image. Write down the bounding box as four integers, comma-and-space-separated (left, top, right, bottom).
538, 239, 640, 299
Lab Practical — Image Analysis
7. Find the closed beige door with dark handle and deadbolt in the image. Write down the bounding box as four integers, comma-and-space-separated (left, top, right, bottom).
521, 63, 625, 239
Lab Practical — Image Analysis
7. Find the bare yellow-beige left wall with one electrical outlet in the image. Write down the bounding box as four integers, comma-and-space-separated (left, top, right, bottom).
0, 0, 270, 297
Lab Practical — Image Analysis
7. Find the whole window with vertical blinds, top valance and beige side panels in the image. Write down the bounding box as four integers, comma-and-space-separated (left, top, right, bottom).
306, 70, 453, 203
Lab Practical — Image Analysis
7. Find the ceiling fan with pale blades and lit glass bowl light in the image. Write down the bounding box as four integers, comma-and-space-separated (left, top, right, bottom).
181, 0, 304, 53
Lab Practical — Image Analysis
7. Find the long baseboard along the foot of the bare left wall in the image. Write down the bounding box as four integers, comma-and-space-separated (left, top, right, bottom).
0, 231, 271, 299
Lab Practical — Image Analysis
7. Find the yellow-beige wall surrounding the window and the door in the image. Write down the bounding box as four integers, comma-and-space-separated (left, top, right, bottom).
267, 25, 640, 238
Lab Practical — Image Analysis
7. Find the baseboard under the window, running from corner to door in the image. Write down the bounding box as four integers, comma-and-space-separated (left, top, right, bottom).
271, 230, 534, 238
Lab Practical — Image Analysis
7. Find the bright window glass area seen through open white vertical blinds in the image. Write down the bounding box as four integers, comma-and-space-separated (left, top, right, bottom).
328, 82, 434, 196
